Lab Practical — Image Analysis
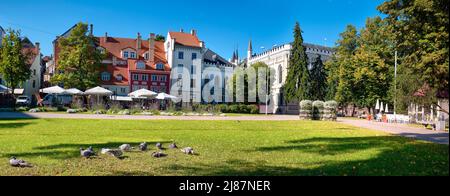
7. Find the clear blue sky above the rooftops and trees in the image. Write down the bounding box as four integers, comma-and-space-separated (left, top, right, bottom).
0, 0, 384, 58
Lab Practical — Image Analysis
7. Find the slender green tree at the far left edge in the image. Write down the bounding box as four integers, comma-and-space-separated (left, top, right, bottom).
0, 29, 31, 99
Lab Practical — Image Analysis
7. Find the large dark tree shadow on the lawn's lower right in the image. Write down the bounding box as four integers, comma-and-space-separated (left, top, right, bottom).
166, 137, 449, 176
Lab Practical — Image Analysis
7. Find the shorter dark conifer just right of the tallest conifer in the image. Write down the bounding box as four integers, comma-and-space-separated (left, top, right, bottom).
311, 55, 327, 100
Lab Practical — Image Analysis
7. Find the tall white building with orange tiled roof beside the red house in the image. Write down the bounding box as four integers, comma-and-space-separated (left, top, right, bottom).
164, 30, 234, 103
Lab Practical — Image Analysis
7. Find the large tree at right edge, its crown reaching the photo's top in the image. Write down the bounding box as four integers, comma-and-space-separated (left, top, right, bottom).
378, 0, 449, 113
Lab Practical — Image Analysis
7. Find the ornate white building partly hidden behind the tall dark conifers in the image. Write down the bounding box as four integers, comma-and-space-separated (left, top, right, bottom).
246, 41, 334, 114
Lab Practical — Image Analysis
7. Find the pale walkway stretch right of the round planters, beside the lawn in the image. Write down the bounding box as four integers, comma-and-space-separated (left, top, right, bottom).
339, 118, 449, 145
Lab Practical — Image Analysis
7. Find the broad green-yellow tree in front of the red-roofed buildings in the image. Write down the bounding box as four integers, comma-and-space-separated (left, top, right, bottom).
52, 23, 104, 90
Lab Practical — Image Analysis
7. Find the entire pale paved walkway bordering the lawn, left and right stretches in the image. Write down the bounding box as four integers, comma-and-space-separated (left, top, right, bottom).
0, 112, 449, 145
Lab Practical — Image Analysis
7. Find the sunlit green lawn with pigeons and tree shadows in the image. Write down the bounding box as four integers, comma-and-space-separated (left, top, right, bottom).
0, 119, 449, 176
